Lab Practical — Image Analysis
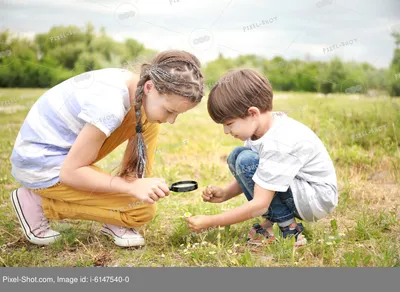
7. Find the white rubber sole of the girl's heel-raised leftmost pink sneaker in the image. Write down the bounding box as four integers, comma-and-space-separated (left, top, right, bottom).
11, 190, 61, 245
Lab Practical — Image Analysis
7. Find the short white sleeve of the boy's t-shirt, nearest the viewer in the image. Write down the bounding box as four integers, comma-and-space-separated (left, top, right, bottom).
253, 141, 313, 192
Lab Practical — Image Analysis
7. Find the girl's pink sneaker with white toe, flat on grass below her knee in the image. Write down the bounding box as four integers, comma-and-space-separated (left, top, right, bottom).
100, 224, 145, 247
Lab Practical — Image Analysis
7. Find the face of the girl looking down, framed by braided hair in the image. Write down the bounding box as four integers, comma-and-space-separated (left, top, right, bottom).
143, 80, 198, 124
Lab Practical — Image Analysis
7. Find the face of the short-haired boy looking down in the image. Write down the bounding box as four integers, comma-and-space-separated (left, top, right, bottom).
223, 116, 257, 141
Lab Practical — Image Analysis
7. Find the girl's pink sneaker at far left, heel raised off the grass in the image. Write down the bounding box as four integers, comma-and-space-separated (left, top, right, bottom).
11, 187, 61, 245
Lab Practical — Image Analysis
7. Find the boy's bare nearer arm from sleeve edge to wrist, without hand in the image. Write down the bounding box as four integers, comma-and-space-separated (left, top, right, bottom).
209, 184, 275, 226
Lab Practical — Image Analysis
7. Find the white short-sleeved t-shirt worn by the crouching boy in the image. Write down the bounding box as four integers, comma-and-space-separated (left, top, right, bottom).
244, 112, 338, 222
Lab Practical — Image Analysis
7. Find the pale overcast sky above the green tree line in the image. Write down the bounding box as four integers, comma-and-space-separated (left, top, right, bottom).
0, 0, 400, 67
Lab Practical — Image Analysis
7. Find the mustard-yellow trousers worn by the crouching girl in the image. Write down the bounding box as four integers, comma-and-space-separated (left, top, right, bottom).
32, 109, 160, 228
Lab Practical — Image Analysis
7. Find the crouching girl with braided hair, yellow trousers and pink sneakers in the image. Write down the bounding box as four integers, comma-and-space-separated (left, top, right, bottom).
11, 51, 203, 246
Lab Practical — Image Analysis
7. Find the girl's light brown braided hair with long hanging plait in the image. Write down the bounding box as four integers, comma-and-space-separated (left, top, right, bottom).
119, 50, 204, 178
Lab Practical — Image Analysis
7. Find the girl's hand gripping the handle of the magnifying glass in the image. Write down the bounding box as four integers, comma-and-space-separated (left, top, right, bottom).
128, 178, 169, 204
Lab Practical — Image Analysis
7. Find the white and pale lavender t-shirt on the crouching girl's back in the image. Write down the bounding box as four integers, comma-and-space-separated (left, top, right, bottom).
11, 68, 131, 189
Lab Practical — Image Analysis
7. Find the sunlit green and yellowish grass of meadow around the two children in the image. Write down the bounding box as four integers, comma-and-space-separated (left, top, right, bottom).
0, 89, 400, 267
